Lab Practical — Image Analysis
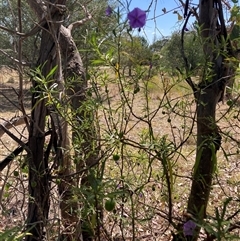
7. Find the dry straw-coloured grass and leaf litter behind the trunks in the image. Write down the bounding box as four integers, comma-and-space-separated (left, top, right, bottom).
0, 65, 240, 241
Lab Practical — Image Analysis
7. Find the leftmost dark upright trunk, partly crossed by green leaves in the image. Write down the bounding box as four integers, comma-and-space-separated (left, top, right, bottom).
25, 2, 63, 241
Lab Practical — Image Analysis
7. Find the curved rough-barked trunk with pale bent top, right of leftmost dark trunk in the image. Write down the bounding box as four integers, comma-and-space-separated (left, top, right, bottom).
60, 26, 98, 240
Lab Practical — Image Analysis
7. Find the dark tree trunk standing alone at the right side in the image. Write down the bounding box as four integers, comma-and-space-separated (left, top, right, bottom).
184, 0, 232, 241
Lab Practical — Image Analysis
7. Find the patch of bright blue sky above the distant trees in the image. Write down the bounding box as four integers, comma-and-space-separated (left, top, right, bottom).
125, 0, 199, 43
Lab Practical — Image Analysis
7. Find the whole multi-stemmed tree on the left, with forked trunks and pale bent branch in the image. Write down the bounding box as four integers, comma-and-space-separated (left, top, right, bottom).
23, 0, 112, 240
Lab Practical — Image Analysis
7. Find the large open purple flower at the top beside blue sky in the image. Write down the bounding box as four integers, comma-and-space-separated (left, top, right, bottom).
128, 8, 147, 28
